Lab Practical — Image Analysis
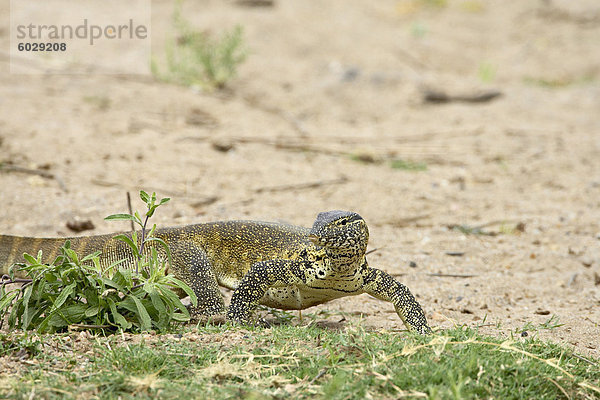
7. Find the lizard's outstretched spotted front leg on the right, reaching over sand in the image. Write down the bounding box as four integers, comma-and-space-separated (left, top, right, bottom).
363, 268, 432, 335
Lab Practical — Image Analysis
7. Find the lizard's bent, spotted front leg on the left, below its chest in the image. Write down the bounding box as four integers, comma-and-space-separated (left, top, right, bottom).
227, 260, 309, 322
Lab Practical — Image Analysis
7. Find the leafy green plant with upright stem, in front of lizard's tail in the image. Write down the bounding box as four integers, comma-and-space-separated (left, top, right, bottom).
0, 191, 197, 332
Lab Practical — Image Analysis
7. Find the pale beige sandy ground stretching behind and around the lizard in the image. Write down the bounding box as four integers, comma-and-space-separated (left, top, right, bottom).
0, 0, 600, 356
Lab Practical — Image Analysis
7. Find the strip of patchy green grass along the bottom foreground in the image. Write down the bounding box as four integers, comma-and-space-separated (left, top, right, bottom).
0, 323, 600, 399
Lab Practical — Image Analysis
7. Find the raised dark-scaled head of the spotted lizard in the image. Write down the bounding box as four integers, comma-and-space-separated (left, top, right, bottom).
308, 210, 369, 254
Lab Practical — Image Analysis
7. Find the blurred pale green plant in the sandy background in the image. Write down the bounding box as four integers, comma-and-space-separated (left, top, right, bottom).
151, 1, 246, 89
